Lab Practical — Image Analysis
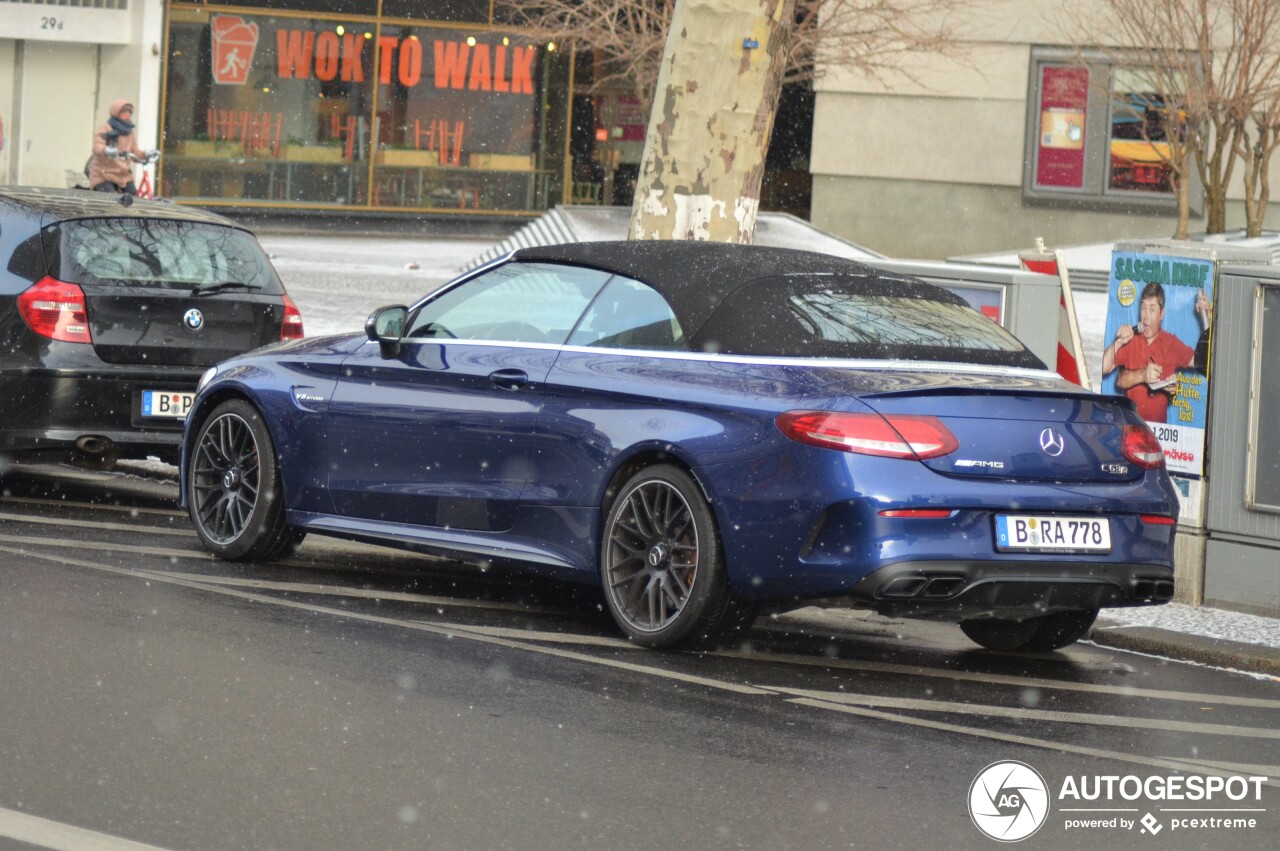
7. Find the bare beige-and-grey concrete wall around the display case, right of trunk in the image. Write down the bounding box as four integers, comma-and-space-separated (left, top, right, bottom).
810, 0, 1280, 257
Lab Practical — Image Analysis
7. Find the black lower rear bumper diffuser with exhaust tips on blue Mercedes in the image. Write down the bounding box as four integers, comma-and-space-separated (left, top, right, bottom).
850, 561, 1174, 621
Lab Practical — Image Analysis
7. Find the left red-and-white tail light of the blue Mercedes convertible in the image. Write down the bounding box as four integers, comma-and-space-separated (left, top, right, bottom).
774, 411, 960, 461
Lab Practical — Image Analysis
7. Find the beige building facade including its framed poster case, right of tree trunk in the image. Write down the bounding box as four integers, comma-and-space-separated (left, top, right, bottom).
810, 0, 1280, 257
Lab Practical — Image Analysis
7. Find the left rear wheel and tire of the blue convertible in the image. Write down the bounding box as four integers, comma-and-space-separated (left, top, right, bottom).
600, 465, 756, 650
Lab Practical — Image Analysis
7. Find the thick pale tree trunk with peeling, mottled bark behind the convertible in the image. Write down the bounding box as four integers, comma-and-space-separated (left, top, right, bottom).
630, 0, 795, 243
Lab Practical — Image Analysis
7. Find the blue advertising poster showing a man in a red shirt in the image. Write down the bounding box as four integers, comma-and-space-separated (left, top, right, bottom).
1102, 251, 1213, 481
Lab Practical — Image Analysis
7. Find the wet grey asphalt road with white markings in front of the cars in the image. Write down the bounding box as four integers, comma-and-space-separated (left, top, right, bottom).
0, 470, 1280, 850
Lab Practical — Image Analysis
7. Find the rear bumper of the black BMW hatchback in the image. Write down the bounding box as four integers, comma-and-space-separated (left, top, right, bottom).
0, 369, 200, 459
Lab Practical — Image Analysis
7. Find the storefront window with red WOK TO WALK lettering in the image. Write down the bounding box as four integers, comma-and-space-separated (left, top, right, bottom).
161, 0, 571, 212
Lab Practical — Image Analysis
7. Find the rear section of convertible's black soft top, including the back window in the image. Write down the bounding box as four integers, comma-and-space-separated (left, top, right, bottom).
694, 274, 1044, 369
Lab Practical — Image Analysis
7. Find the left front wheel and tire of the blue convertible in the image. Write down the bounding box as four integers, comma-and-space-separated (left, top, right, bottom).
186, 399, 306, 562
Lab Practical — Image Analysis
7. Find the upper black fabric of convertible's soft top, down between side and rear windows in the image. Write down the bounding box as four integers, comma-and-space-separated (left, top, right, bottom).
515, 239, 931, 333
